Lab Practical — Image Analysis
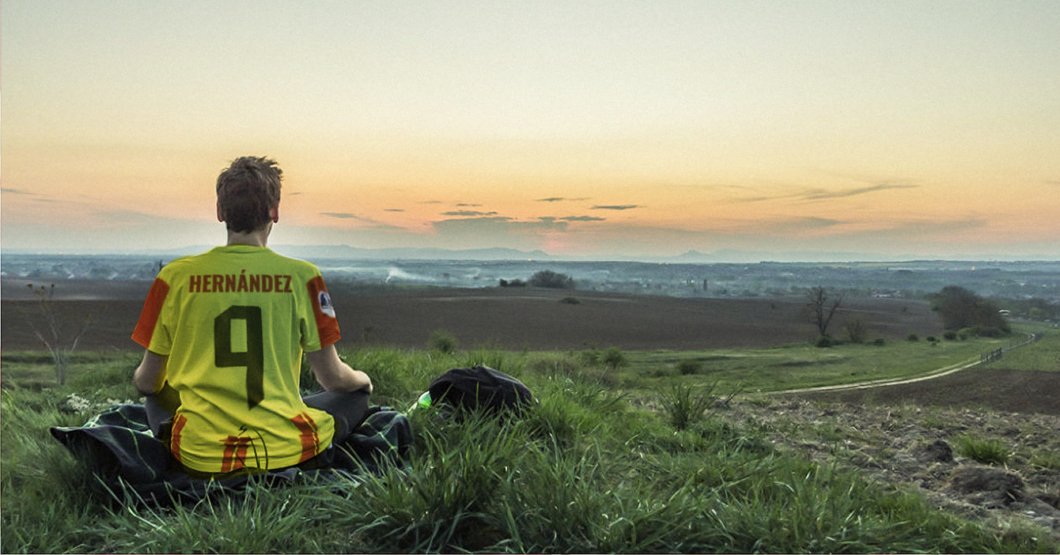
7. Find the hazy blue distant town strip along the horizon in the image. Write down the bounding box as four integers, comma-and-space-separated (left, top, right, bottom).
8, 253, 1060, 313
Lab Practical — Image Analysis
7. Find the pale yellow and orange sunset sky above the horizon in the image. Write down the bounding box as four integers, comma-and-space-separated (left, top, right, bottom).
0, 0, 1060, 259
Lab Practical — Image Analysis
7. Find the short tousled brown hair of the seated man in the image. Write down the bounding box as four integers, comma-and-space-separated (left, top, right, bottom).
217, 156, 283, 233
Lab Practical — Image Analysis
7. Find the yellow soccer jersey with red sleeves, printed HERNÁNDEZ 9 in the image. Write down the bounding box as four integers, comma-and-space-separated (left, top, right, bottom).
133, 245, 339, 472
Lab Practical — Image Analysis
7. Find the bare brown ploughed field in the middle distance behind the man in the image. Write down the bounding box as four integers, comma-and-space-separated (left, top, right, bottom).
0, 280, 940, 350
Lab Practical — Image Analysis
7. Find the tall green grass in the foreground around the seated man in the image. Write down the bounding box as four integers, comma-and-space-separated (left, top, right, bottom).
0, 346, 1060, 553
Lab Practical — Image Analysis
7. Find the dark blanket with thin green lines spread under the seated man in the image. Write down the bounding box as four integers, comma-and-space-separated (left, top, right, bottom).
51, 405, 412, 505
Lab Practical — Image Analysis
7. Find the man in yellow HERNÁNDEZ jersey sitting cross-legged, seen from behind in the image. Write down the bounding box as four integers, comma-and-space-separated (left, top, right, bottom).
133, 157, 372, 478
